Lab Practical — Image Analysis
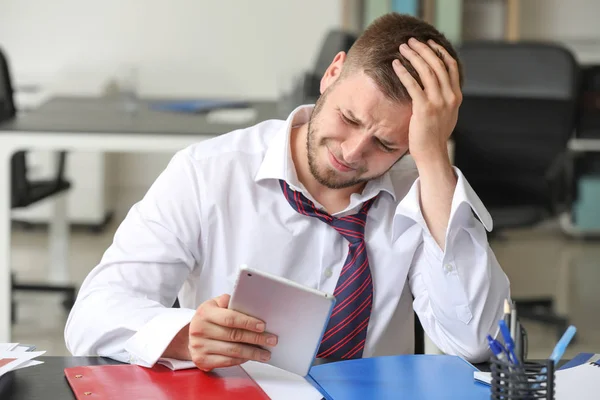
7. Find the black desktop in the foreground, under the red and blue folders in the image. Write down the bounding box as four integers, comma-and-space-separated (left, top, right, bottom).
0, 357, 567, 400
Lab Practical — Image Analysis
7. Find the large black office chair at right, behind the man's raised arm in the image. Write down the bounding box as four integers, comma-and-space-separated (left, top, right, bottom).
453, 42, 579, 335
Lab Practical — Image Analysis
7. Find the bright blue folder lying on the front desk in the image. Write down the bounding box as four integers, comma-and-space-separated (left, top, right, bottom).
307, 355, 490, 400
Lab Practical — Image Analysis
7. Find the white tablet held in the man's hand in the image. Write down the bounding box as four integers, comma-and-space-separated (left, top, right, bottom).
229, 266, 335, 376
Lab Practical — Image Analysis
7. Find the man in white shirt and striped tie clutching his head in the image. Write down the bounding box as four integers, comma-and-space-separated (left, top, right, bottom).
65, 14, 509, 370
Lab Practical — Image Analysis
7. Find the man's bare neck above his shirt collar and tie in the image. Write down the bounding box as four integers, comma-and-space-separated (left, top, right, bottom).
290, 124, 365, 214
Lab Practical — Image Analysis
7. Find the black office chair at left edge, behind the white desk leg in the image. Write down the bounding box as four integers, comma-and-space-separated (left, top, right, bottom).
0, 49, 76, 322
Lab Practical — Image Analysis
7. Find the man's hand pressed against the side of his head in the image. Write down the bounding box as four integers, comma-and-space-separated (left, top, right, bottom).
392, 38, 462, 164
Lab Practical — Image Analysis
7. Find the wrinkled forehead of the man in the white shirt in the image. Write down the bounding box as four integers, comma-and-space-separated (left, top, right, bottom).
329, 72, 412, 134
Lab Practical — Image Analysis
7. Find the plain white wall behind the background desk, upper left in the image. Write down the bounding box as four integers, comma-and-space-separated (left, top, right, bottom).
0, 0, 341, 196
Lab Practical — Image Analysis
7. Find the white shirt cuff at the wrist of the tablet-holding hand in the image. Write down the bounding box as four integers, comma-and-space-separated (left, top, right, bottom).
125, 308, 195, 368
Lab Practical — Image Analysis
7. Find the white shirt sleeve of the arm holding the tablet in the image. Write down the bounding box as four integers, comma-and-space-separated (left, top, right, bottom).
65, 151, 201, 365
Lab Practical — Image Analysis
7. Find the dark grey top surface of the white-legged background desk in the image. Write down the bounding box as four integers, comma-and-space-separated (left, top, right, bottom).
0, 97, 285, 135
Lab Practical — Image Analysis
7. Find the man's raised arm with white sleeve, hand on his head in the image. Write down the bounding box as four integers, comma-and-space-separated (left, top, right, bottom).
393, 39, 510, 362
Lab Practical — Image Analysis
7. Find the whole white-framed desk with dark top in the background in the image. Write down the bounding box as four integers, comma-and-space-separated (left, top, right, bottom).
0, 97, 278, 342
